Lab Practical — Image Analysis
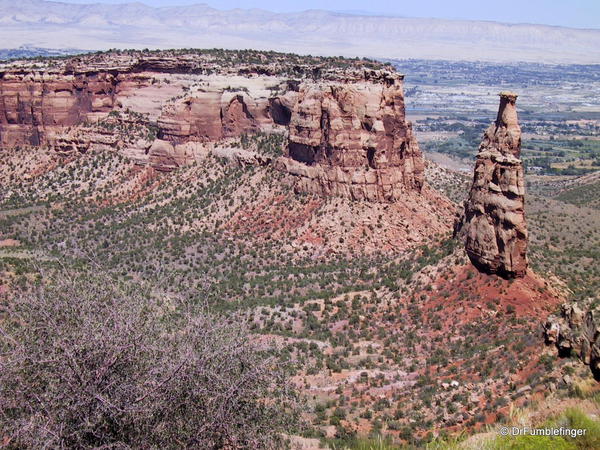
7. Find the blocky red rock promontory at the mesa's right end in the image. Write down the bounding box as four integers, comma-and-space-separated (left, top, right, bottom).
279, 71, 424, 201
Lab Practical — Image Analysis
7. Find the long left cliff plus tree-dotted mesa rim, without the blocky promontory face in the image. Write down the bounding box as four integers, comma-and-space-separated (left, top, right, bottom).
0, 51, 380, 146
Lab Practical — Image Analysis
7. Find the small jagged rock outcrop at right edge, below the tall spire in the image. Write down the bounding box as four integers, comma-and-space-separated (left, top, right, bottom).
544, 303, 600, 380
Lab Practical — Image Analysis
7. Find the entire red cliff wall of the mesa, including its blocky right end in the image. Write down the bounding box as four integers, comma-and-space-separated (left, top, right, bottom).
0, 52, 424, 202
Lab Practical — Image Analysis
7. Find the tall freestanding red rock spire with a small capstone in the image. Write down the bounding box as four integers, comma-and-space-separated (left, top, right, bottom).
460, 93, 528, 277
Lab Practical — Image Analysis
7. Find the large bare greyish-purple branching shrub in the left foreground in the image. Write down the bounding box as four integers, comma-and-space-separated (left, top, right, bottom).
0, 274, 298, 449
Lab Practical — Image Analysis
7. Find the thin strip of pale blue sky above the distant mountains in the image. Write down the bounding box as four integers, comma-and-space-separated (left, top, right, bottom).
56, 0, 600, 28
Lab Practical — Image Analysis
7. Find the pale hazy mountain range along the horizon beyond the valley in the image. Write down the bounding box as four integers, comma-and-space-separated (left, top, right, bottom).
0, 0, 600, 63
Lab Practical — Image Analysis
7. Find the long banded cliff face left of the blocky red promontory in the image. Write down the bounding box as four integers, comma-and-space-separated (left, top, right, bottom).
0, 61, 280, 147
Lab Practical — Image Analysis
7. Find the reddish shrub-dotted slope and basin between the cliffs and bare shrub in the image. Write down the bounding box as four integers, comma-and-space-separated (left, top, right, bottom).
0, 136, 584, 443
